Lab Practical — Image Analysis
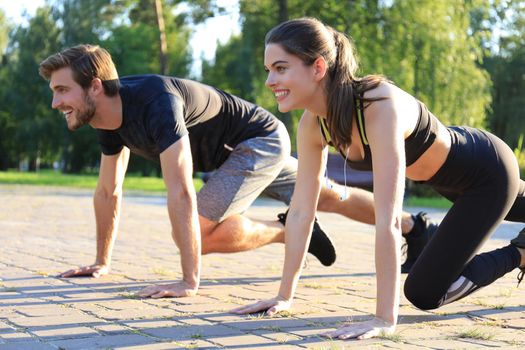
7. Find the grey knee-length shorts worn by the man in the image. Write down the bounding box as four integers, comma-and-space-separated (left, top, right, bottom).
197, 123, 297, 222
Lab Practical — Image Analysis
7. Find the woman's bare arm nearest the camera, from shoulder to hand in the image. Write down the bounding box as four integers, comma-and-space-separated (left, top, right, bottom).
323, 85, 405, 339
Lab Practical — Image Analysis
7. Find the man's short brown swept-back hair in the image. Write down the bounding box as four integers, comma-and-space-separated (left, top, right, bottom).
38, 45, 120, 96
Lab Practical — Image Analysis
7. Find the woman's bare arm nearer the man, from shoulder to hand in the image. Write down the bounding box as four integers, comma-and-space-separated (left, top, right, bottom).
232, 111, 326, 315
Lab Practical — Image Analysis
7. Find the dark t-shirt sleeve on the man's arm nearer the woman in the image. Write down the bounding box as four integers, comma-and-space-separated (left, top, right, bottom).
147, 93, 188, 153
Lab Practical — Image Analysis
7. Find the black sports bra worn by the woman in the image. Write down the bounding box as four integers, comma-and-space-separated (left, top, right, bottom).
317, 98, 438, 170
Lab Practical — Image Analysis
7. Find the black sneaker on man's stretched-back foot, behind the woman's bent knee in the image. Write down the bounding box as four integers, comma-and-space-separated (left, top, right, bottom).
401, 212, 439, 273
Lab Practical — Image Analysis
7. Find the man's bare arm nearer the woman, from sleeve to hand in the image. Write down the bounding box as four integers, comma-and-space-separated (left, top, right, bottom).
138, 136, 201, 298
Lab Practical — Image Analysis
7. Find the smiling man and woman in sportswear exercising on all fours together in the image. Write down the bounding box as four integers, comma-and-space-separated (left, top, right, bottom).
40, 18, 525, 339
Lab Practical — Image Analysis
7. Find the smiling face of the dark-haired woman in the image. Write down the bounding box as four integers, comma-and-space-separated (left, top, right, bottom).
264, 44, 320, 112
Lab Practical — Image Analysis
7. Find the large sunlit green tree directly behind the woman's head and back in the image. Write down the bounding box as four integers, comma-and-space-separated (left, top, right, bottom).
203, 0, 491, 150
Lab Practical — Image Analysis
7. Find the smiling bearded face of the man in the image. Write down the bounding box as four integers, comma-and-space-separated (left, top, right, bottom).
49, 67, 96, 130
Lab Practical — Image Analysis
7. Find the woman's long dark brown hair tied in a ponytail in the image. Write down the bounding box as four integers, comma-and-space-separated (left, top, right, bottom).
265, 18, 386, 149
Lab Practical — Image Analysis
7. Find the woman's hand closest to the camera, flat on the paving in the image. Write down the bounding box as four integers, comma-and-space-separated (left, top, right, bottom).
321, 317, 396, 340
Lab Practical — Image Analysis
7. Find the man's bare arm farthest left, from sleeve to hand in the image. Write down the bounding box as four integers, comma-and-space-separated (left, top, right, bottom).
60, 147, 129, 277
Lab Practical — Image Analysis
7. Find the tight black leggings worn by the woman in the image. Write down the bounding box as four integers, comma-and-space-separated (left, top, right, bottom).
405, 127, 525, 310
